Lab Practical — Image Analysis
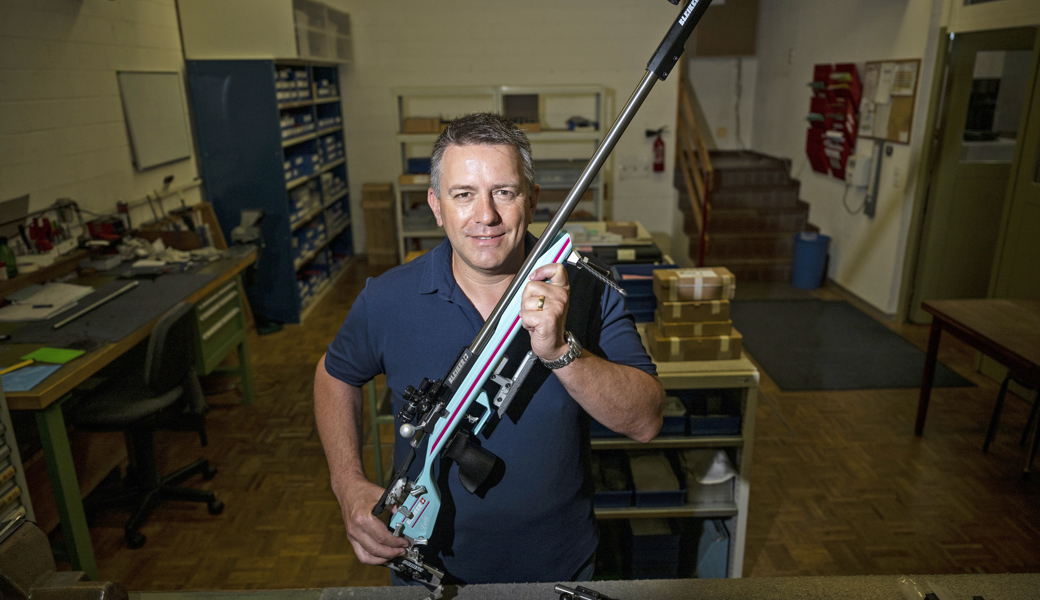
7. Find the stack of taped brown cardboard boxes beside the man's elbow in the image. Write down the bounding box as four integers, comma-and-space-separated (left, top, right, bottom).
646, 267, 742, 362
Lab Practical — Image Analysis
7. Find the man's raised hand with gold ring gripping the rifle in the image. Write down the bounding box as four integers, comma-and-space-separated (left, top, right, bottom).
520, 263, 571, 361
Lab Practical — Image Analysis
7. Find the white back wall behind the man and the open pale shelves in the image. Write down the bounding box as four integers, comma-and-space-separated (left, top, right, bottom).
331, 0, 677, 254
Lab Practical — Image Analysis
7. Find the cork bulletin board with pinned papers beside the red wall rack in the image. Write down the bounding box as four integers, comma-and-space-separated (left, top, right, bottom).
859, 58, 920, 144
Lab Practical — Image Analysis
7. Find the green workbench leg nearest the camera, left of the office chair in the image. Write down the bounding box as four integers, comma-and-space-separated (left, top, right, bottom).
36, 400, 98, 581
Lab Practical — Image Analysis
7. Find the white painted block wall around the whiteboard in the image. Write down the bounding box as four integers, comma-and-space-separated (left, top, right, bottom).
0, 0, 199, 228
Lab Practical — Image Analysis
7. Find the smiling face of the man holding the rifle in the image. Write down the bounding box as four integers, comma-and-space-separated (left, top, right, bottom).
427, 145, 538, 277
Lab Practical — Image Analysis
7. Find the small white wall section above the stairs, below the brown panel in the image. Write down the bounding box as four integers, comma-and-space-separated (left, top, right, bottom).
687, 56, 758, 150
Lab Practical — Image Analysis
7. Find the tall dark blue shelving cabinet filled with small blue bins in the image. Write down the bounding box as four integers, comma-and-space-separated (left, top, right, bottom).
187, 59, 353, 322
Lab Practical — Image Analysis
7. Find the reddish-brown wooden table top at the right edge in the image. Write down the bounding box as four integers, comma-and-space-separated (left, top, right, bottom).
920, 298, 1040, 368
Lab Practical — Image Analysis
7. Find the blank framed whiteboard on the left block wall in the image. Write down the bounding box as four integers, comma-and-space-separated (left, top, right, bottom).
115, 71, 191, 171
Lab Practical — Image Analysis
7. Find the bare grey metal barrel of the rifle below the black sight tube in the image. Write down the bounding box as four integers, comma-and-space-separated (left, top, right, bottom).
469, 71, 657, 355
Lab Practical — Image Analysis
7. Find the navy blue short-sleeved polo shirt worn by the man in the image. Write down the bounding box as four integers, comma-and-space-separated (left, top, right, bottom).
326, 235, 656, 583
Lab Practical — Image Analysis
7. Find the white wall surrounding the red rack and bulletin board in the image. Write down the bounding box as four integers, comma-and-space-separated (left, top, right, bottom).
752, 0, 942, 314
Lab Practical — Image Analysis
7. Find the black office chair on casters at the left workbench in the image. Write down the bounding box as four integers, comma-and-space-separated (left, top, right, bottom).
69, 303, 224, 548
